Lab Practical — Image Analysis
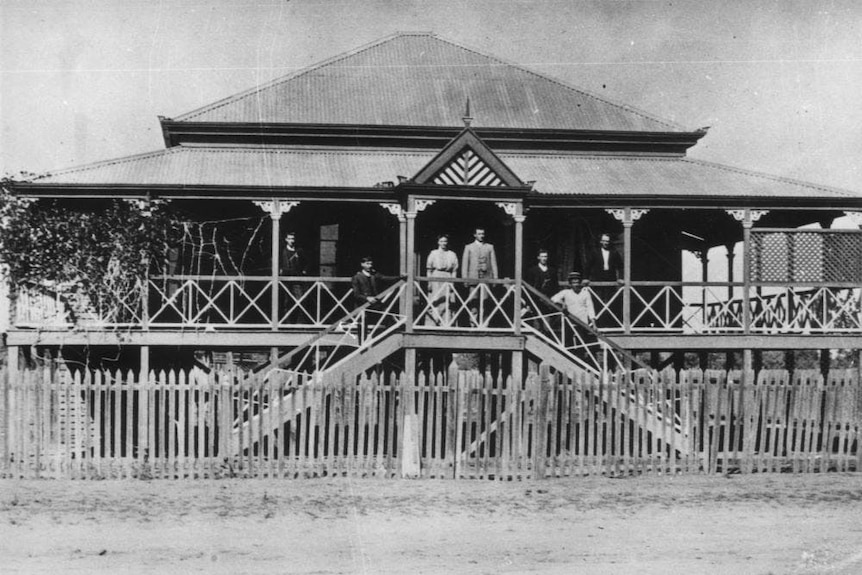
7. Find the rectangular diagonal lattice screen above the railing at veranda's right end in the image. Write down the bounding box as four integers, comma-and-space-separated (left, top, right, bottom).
750, 230, 862, 282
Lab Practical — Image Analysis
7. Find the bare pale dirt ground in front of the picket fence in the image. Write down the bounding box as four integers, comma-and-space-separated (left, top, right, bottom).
0, 474, 862, 574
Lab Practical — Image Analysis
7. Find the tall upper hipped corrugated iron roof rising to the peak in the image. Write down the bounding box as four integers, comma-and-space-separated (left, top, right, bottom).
175, 33, 686, 132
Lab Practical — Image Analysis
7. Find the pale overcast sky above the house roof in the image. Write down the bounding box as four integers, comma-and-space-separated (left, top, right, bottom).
0, 0, 862, 193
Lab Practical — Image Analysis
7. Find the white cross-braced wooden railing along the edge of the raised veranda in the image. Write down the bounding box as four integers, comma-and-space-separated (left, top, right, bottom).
12, 276, 862, 334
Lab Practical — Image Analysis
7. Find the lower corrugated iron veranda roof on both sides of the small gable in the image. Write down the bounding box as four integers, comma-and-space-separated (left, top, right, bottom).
25, 146, 860, 199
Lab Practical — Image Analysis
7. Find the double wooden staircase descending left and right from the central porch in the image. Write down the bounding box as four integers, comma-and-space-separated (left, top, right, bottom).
231, 282, 692, 462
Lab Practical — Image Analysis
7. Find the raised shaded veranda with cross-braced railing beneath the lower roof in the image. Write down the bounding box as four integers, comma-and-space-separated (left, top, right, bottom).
10, 199, 862, 369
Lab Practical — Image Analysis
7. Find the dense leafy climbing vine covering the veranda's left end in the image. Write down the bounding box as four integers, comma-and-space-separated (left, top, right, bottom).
0, 186, 180, 321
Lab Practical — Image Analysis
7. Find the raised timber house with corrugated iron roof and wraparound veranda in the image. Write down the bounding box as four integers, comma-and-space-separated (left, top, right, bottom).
4, 33, 862, 482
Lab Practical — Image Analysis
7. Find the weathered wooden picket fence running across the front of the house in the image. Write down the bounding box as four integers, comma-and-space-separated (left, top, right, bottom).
0, 365, 862, 480
